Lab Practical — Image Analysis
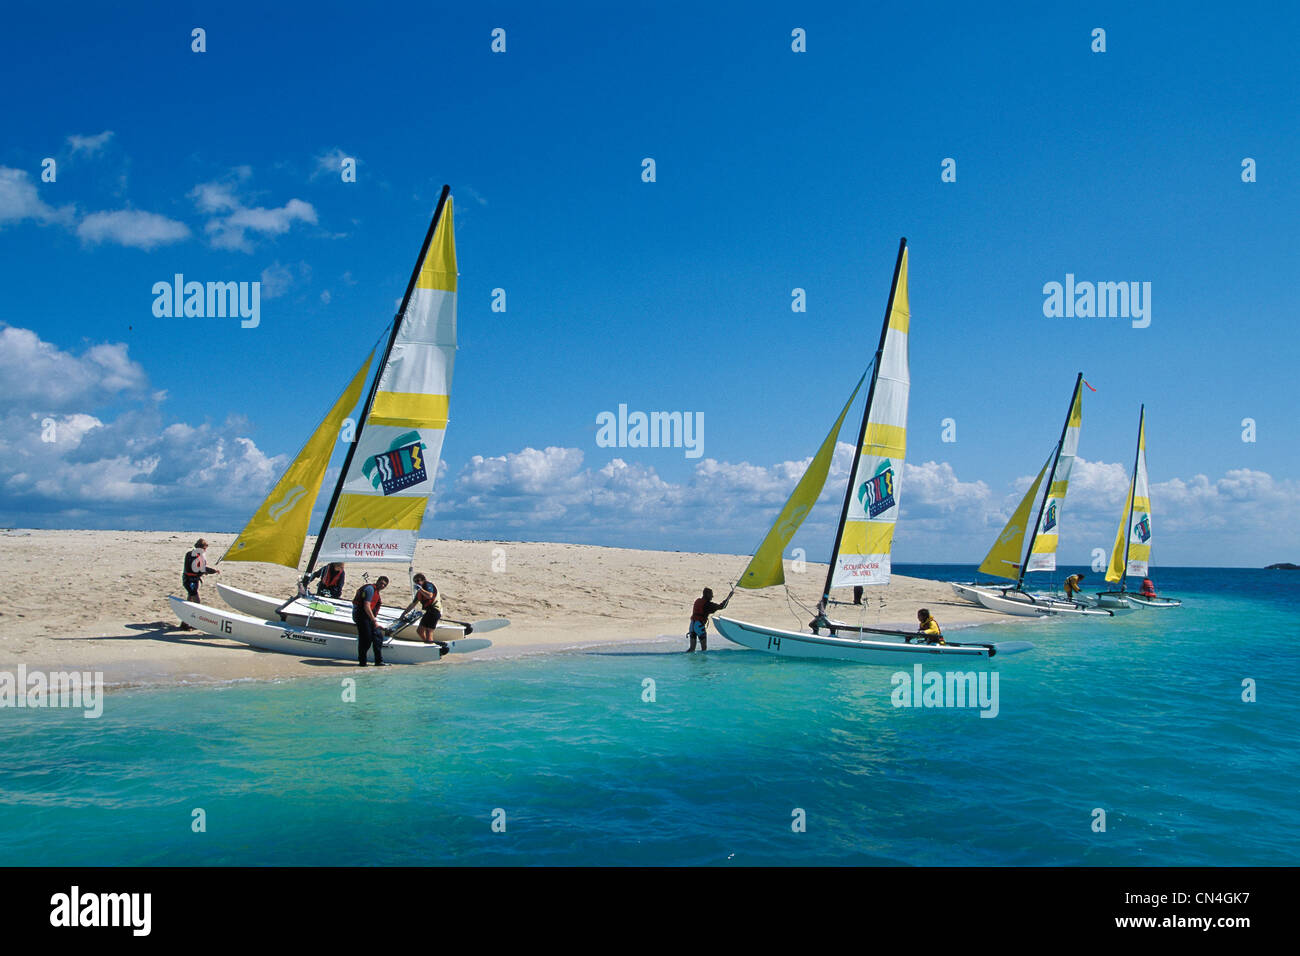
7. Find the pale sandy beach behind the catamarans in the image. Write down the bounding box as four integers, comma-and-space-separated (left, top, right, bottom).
0, 529, 1023, 687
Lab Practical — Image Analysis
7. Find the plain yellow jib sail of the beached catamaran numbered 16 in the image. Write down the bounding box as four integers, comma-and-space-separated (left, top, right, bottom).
221, 355, 371, 568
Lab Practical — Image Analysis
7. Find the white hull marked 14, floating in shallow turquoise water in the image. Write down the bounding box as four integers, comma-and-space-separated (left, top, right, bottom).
714, 617, 1034, 665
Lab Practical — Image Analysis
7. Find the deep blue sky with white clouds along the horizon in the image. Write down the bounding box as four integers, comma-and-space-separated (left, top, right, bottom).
0, 3, 1300, 564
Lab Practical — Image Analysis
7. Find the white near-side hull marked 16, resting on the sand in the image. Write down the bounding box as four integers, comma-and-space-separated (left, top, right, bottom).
168, 597, 491, 663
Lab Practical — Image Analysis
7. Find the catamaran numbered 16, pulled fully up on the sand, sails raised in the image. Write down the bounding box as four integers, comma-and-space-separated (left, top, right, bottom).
173, 186, 510, 662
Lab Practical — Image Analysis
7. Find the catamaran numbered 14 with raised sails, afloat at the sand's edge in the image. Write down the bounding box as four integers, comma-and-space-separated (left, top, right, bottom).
714, 239, 1034, 665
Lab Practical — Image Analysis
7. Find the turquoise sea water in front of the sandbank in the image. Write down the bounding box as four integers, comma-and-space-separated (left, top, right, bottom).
0, 566, 1300, 865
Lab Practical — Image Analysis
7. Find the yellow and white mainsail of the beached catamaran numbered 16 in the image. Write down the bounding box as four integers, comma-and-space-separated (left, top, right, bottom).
316, 195, 456, 563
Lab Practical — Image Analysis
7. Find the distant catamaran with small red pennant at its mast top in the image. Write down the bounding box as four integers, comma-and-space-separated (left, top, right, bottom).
952, 372, 1113, 618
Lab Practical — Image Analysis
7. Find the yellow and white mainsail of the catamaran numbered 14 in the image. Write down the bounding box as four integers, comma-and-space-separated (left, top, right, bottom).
827, 243, 911, 589
